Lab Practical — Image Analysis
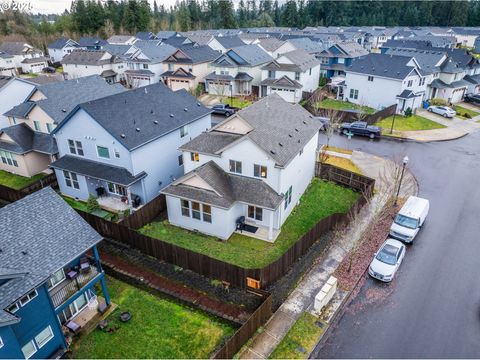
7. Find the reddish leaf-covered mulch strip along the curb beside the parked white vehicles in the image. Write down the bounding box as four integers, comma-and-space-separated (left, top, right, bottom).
333, 206, 400, 290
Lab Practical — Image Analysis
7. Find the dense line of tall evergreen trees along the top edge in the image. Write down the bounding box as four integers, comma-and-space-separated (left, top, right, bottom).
0, 0, 480, 48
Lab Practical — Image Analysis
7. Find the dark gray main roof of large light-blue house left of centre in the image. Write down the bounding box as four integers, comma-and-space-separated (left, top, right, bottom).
59, 83, 211, 150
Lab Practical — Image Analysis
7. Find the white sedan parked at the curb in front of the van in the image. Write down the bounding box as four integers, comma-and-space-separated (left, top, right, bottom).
368, 239, 405, 282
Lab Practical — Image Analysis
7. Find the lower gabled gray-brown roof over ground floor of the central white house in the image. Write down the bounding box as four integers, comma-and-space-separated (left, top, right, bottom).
162, 161, 283, 210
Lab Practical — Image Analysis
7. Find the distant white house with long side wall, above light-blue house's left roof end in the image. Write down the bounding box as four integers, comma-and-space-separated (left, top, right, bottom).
61, 50, 126, 83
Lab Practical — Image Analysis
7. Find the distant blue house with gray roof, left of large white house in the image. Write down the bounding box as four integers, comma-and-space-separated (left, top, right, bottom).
318, 42, 368, 79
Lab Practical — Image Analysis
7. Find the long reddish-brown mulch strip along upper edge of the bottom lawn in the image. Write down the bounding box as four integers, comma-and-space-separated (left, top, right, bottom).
100, 250, 250, 323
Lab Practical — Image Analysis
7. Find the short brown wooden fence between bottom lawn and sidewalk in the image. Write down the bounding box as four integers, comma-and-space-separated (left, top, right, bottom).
212, 292, 272, 359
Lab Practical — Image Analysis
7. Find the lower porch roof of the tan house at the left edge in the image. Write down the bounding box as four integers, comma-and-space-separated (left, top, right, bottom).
0, 123, 58, 154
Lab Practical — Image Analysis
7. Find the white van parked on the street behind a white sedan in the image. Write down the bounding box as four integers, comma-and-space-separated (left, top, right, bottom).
390, 196, 430, 243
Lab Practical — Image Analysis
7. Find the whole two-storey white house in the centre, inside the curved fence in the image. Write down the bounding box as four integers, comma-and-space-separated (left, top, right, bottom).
162, 94, 319, 242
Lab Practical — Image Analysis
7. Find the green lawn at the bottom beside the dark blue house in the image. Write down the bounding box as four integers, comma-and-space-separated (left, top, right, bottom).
72, 277, 235, 359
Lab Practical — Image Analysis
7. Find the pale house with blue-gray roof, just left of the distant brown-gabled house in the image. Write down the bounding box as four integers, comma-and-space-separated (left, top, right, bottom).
124, 40, 177, 87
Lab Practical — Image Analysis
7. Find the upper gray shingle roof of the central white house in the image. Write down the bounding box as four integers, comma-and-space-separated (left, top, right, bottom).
181, 93, 320, 167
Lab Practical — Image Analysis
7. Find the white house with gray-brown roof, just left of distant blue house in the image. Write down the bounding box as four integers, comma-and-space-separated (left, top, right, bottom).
260, 49, 320, 103
